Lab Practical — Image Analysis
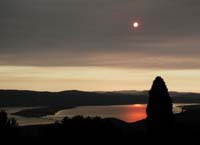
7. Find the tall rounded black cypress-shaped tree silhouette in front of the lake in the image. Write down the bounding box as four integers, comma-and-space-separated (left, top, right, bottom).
146, 77, 174, 135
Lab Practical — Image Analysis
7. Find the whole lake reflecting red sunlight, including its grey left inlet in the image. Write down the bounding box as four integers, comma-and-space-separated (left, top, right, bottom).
0, 104, 194, 125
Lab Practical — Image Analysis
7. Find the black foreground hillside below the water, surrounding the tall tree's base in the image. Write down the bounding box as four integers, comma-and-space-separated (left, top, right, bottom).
0, 110, 200, 144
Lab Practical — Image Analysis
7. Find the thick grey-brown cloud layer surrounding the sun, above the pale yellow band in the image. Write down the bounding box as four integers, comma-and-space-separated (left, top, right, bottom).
0, 0, 200, 69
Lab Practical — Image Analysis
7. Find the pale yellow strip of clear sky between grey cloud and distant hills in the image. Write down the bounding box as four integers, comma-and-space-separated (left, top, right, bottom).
0, 66, 200, 92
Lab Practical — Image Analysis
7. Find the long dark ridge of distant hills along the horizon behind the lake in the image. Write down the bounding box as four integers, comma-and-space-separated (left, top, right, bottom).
0, 90, 200, 107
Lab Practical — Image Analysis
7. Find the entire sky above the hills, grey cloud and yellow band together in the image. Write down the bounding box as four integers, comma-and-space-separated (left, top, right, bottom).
0, 0, 200, 92
